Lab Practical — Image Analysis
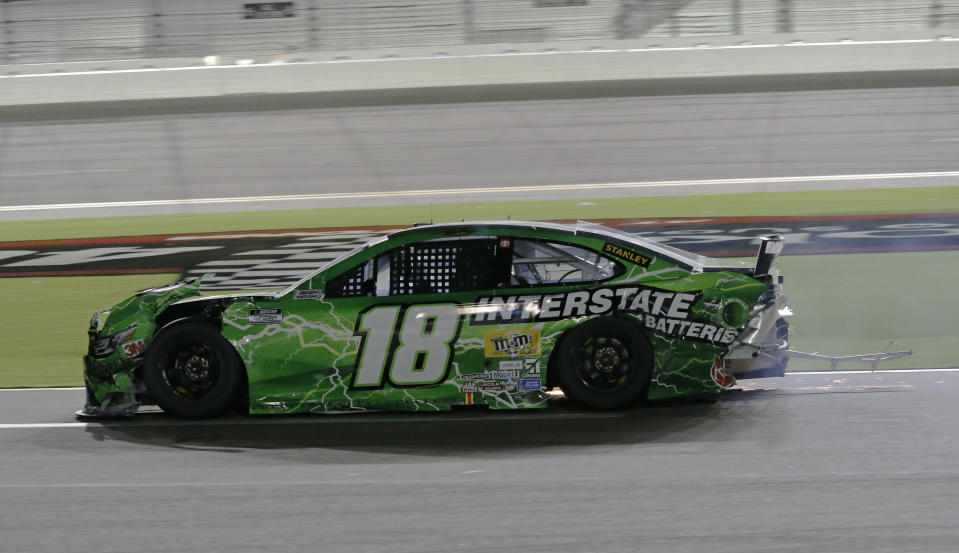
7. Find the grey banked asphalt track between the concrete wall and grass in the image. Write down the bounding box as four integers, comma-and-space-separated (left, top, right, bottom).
0, 86, 959, 219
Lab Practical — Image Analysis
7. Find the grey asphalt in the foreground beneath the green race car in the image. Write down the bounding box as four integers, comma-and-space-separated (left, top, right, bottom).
0, 371, 959, 553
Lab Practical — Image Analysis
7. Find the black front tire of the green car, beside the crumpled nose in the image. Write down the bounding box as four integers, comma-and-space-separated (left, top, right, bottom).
143, 321, 245, 419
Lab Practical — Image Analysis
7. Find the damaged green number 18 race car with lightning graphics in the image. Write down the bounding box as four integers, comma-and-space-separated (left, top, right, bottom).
78, 221, 790, 418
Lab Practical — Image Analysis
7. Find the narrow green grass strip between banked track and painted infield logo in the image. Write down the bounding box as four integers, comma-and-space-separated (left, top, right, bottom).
0, 186, 959, 241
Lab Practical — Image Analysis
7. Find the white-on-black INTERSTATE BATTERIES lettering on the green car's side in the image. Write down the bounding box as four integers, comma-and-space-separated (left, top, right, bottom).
470, 286, 737, 344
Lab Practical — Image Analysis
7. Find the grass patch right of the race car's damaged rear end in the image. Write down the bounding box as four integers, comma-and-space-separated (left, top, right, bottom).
780, 251, 959, 370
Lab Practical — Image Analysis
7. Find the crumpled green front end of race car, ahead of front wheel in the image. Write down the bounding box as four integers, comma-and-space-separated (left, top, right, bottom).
78, 278, 200, 417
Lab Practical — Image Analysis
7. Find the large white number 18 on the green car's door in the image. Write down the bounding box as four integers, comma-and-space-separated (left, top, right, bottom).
350, 303, 462, 388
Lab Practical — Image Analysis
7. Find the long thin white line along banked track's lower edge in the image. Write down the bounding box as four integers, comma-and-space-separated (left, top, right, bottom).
0, 171, 959, 212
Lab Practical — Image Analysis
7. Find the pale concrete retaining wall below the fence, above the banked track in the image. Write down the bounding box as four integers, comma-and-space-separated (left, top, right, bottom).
0, 30, 959, 107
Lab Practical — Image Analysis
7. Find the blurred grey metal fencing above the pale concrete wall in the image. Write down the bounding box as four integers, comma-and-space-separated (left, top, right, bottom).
0, 0, 959, 64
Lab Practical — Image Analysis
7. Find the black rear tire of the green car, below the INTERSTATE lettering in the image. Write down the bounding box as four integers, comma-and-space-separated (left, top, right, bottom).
554, 317, 653, 409
